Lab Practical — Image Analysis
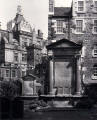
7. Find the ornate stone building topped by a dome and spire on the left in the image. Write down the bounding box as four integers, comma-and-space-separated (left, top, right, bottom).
0, 6, 43, 80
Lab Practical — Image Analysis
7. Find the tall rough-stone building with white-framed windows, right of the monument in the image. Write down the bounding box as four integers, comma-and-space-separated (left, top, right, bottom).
48, 0, 97, 95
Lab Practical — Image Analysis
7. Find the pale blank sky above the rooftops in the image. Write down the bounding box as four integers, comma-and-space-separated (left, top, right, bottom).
0, 0, 72, 38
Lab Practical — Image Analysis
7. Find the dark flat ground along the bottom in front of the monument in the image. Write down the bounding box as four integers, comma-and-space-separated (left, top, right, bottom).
23, 109, 97, 120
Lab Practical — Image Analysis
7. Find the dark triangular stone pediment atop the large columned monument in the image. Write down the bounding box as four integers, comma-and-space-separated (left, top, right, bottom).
47, 39, 82, 50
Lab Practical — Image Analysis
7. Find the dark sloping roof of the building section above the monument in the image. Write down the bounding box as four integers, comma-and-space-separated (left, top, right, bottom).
54, 7, 72, 16
